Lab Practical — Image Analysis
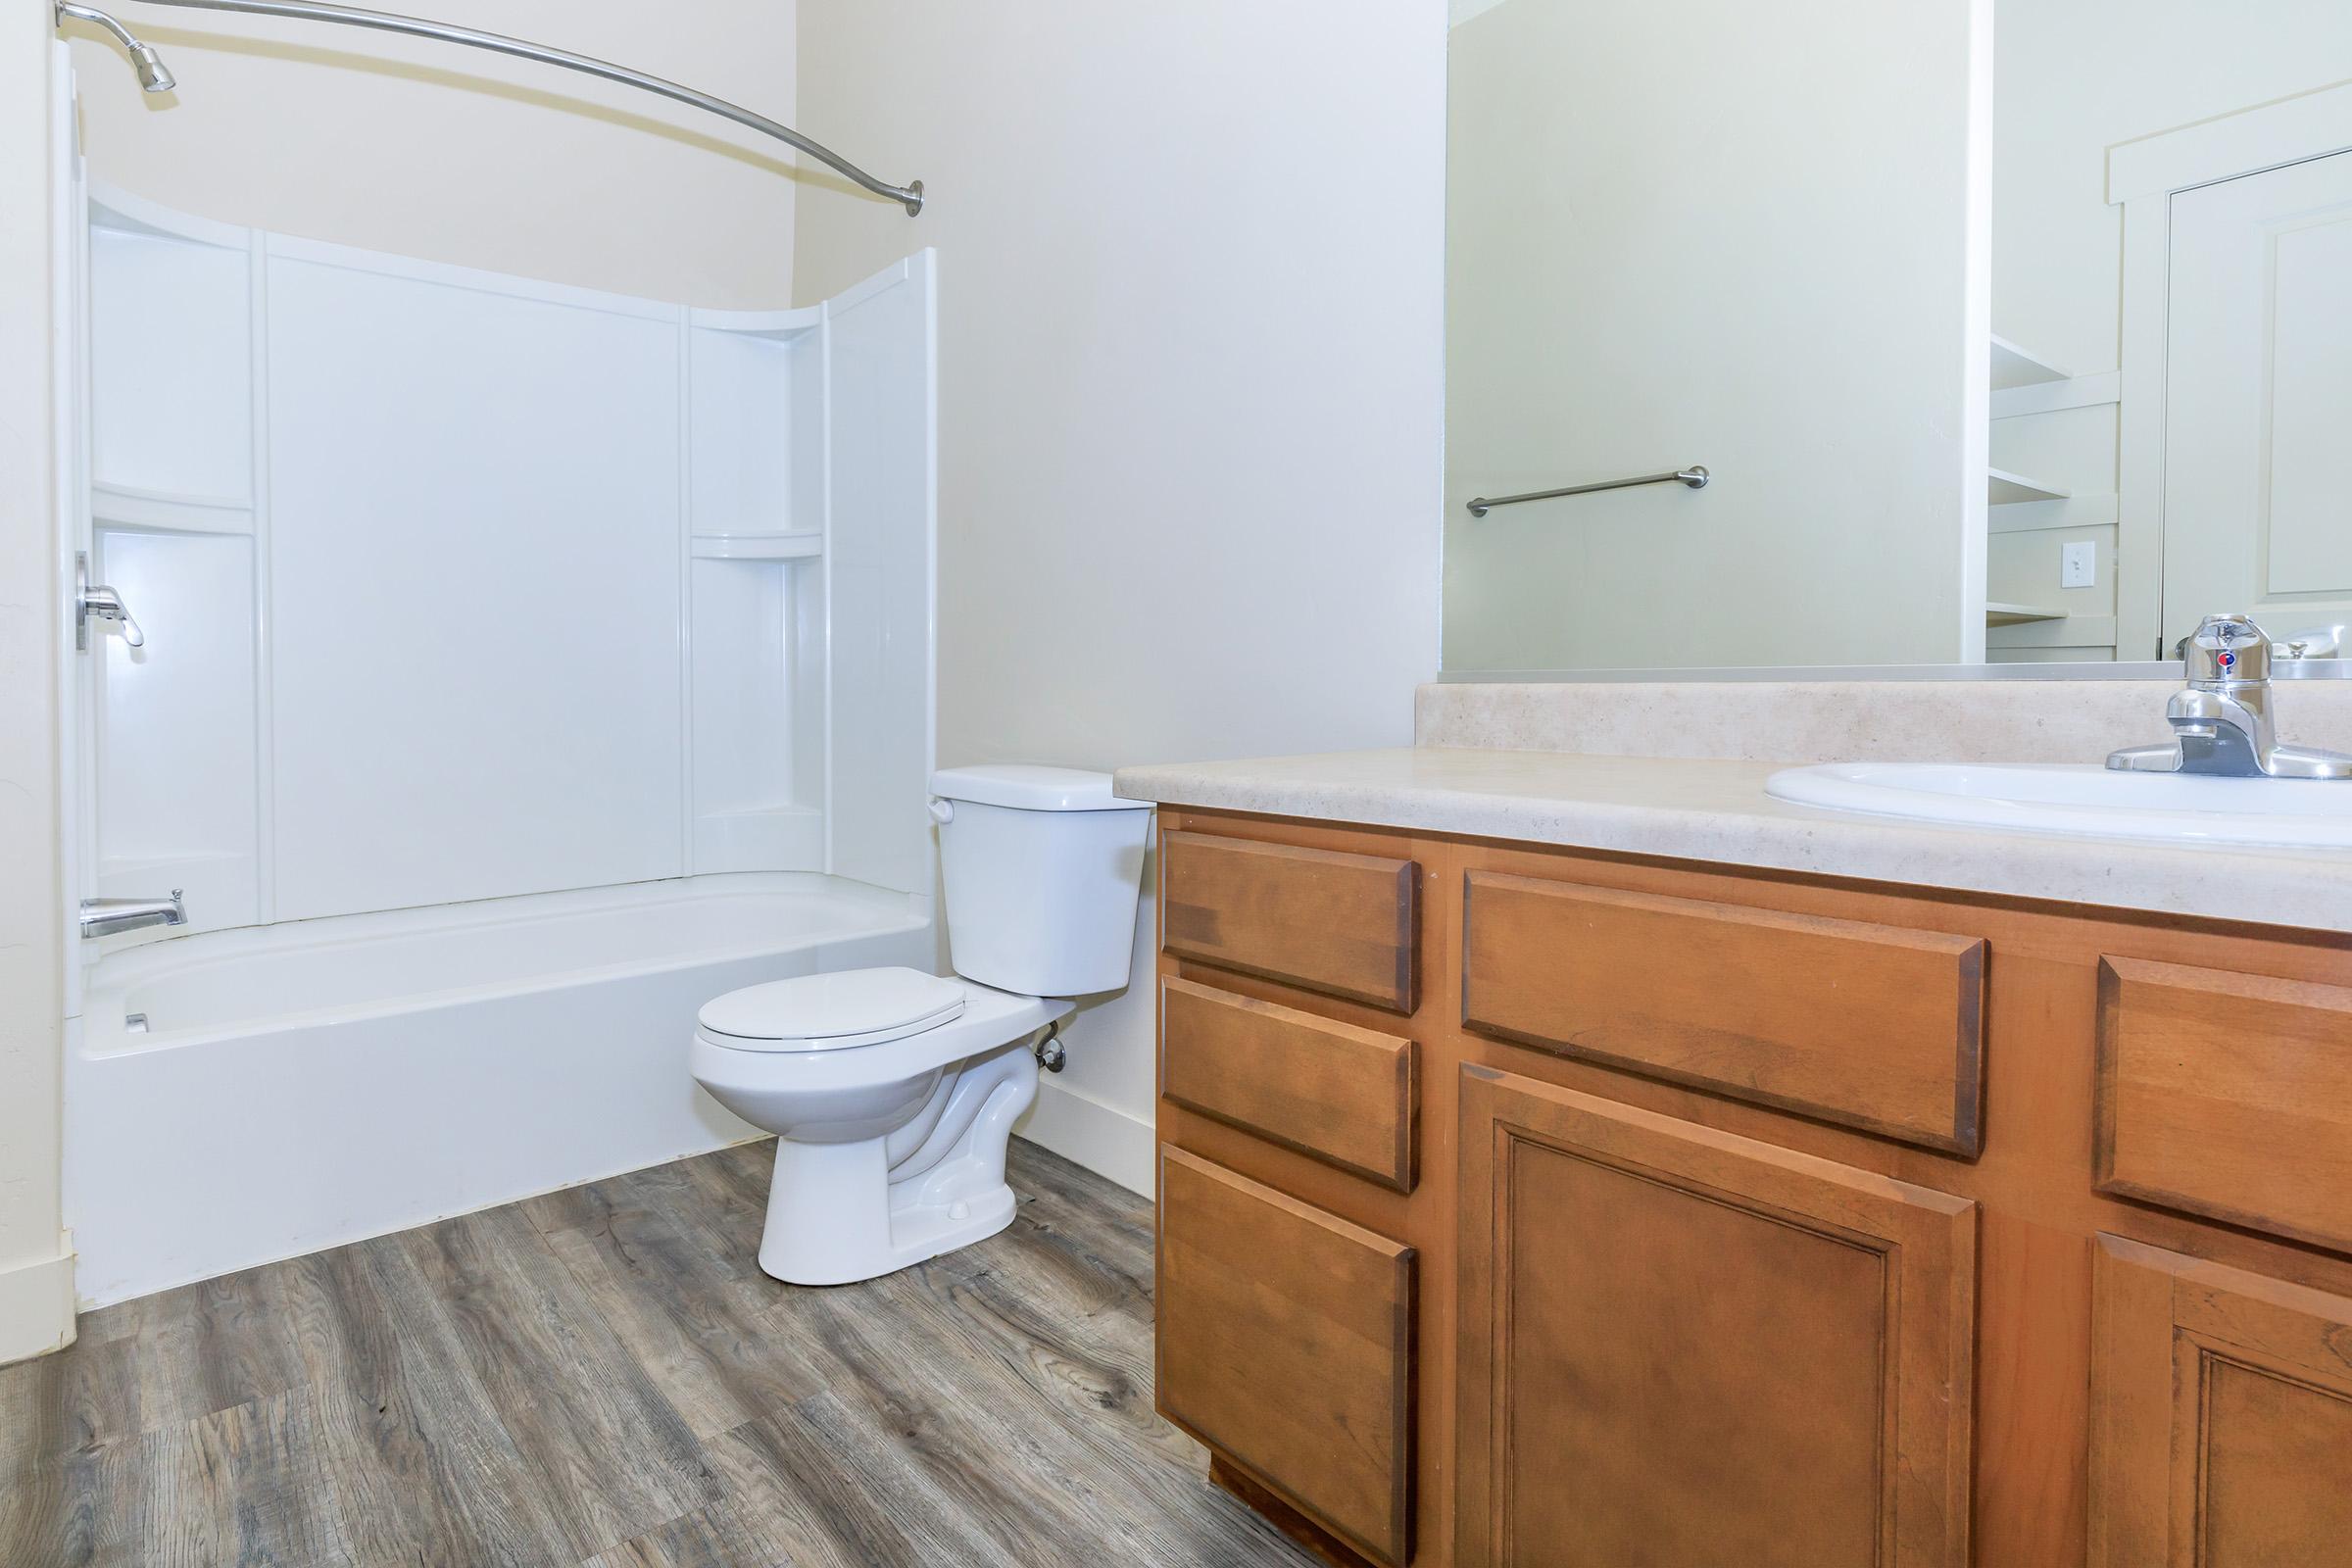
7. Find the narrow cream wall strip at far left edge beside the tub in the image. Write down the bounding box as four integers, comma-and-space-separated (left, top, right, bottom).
0, 27, 73, 1361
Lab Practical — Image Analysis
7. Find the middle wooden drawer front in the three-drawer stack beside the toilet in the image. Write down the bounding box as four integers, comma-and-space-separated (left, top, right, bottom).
1159, 978, 1418, 1192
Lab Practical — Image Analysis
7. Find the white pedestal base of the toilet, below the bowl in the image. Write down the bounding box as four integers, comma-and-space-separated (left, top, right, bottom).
760, 1044, 1037, 1286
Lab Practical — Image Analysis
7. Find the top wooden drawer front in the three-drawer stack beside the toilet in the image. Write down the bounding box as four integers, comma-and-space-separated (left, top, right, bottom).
1159, 832, 1421, 1013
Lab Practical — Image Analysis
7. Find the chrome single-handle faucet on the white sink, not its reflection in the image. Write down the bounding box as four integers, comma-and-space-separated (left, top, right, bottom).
2107, 615, 2352, 778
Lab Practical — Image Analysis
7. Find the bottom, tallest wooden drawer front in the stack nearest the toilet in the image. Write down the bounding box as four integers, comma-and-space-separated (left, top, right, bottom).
1157, 1145, 1413, 1563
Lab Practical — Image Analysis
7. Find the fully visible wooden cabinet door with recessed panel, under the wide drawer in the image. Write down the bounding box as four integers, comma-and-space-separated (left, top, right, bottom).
1456, 1065, 1976, 1568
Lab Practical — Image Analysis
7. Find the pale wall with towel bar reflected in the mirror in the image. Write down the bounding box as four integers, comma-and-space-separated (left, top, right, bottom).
1446, 0, 1989, 670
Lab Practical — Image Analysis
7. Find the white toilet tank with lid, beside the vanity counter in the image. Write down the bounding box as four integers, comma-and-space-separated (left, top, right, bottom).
931, 764, 1152, 997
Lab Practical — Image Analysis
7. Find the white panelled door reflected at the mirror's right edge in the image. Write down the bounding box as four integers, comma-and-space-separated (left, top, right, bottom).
2164, 153, 2352, 649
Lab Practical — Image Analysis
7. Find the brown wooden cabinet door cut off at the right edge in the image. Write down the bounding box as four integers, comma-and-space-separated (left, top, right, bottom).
2091, 1237, 2352, 1568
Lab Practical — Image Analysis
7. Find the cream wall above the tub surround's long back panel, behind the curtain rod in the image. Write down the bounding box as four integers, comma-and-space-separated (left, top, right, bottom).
64, 0, 804, 308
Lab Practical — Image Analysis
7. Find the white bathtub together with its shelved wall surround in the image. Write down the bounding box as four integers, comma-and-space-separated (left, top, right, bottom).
55, 190, 939, 1306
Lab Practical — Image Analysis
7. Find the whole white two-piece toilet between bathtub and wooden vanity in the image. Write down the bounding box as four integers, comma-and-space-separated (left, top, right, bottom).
694, 766, 1151, 1286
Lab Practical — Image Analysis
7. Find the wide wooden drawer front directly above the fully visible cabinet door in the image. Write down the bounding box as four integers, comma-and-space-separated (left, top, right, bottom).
1463, 872, 1985, 1154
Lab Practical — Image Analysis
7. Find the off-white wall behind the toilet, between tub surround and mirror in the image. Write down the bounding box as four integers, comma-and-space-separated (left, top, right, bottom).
795, 0, 1446, 1190
